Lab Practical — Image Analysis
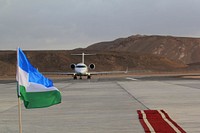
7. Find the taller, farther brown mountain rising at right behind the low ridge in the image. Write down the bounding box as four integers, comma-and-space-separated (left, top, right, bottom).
87, 35, 200, 64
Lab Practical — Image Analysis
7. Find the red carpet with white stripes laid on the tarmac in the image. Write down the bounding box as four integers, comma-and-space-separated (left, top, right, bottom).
137, 110, 186, 133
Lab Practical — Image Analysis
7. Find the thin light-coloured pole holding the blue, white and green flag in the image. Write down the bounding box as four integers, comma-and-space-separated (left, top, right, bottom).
16, 47, 22, 133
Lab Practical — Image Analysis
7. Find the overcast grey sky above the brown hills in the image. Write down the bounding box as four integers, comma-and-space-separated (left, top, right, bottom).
0, 0, 200, 50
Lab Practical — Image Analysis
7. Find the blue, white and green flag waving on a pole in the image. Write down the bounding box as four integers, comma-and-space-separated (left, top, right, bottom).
16, 48, 61, 109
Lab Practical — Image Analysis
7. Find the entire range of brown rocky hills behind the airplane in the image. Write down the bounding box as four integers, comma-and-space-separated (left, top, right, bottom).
0, 35, 200, 76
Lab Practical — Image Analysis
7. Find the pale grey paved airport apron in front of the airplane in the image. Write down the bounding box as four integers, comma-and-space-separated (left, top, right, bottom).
0, 76, 200, 133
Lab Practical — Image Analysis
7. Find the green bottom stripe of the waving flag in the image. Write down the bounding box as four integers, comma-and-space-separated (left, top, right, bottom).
20, 86, 61, 109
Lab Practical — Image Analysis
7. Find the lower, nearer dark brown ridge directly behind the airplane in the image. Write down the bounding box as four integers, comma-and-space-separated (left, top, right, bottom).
0, 49, 187, 76
